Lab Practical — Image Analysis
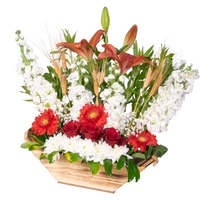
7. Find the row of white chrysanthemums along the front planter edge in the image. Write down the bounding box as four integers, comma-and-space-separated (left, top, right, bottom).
43, 133, 129, 165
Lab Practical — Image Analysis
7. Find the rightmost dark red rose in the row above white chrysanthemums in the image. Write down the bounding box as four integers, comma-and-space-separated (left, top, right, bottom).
102, 127, 126, 147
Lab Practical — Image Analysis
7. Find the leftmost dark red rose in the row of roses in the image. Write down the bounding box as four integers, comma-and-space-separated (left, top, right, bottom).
61, 121, 80, 138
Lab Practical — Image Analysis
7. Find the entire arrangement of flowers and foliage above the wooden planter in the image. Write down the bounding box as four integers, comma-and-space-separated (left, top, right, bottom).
16, 7, 199, 182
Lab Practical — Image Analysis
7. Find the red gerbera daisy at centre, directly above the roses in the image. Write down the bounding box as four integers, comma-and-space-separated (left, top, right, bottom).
78, 104, 108, 127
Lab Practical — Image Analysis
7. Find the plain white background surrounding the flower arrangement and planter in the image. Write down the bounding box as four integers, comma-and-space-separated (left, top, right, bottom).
0, 0, 200, 200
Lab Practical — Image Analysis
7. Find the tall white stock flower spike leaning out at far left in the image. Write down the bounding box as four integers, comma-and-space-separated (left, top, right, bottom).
17, 38, 63, 113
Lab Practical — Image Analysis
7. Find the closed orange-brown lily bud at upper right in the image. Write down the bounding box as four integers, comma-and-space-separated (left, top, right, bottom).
123, 24, 137, 52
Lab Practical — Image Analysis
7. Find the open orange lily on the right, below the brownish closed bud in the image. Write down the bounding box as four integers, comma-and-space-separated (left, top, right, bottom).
98, 44, 153, 74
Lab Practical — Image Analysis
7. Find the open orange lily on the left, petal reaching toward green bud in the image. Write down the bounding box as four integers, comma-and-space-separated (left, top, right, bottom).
56, 30, 106, 61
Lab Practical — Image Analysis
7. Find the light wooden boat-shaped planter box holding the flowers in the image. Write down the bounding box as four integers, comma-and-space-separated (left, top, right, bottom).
24, 131, 158, 193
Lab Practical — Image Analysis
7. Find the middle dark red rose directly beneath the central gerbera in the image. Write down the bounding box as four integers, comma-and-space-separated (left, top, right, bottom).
80, 122, 102, 142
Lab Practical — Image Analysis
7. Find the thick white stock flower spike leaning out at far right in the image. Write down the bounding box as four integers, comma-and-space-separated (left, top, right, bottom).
139, 61, 199, 133
